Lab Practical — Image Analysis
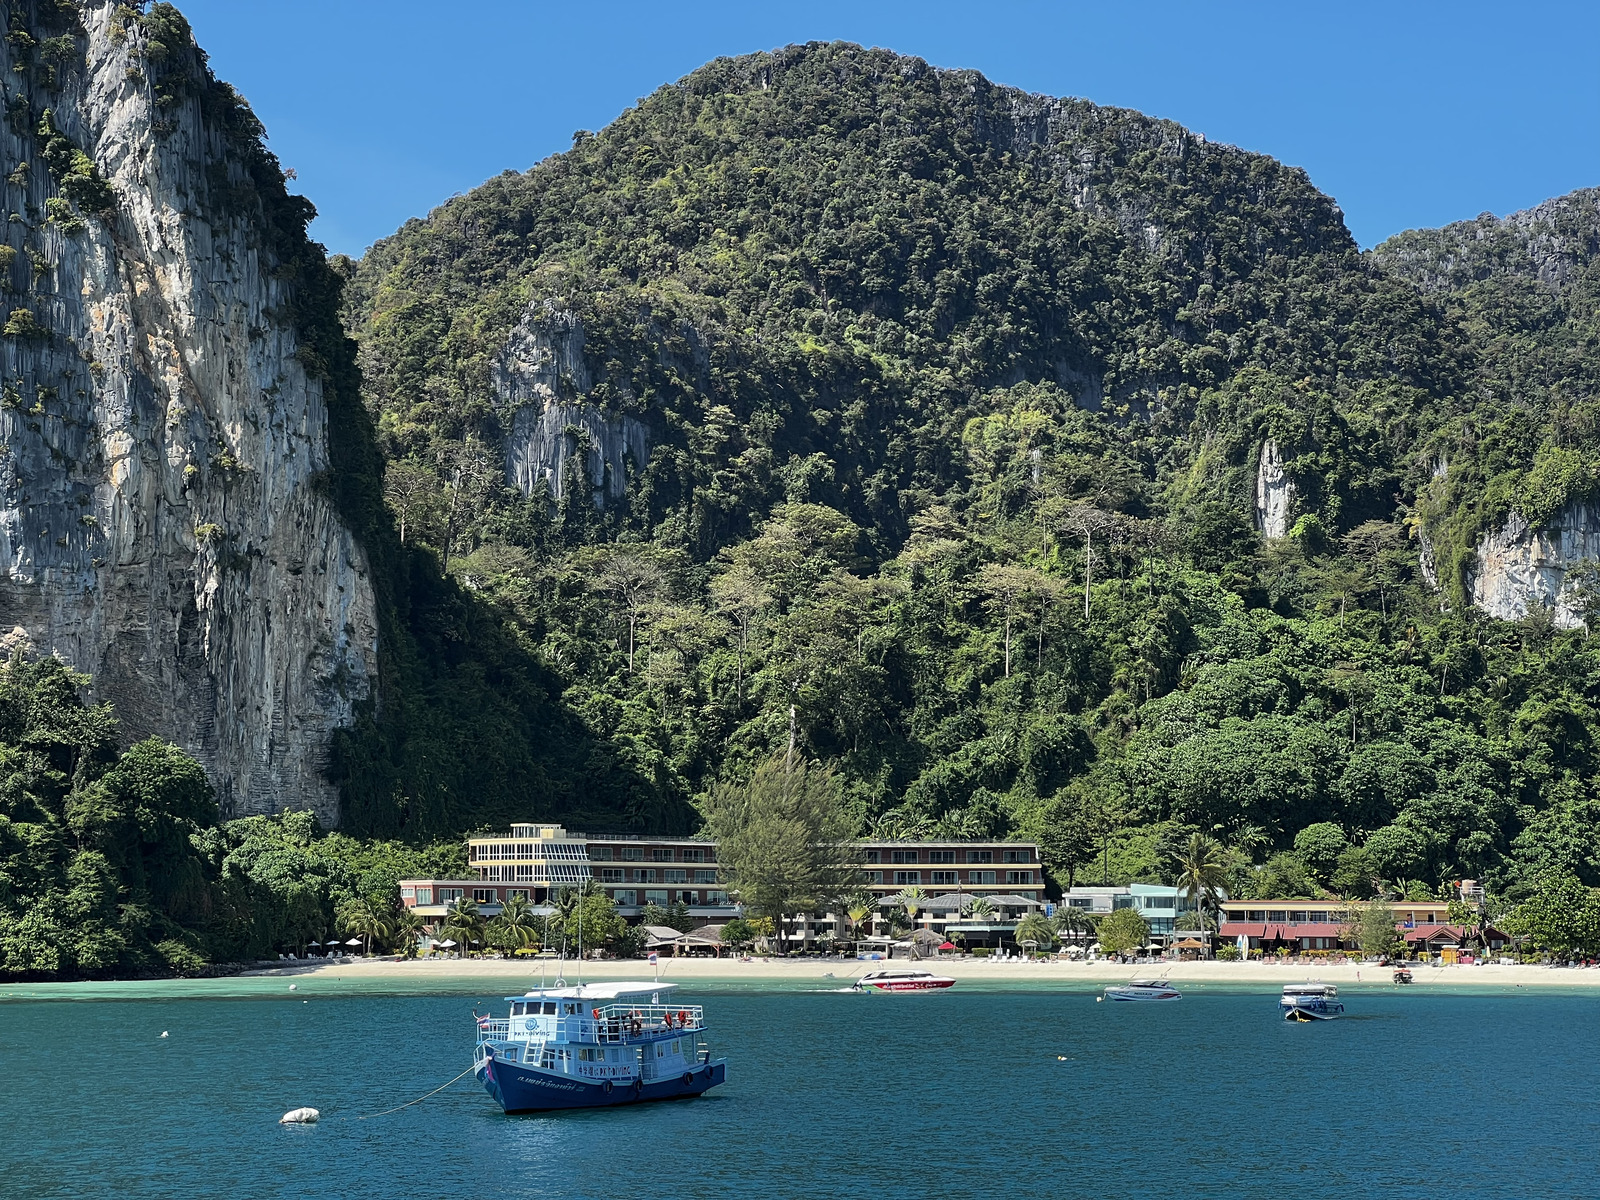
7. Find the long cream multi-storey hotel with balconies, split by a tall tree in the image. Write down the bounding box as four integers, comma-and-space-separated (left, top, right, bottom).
400, 824, 1045, 942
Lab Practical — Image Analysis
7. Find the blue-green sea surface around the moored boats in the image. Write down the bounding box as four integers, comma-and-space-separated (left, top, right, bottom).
0, 968, 1600, 1200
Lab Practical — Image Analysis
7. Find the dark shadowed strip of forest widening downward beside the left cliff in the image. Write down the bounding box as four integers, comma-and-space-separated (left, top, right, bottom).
310, 259, 694, 840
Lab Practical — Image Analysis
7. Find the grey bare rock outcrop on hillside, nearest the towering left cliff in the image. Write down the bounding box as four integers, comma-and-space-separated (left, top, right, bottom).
491, 304, 650, 509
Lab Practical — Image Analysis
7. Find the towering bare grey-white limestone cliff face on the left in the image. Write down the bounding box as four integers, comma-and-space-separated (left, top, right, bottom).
0, 0, 376, 822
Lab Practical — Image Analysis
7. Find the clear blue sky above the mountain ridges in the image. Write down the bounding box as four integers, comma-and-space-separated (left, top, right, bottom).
179, 0, 1600, 254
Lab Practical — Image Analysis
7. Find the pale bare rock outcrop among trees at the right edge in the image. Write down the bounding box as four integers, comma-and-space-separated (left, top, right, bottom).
1467, 504, 1600, 629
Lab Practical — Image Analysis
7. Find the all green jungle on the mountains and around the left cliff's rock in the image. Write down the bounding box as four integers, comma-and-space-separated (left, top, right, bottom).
0, 18, 1600, 973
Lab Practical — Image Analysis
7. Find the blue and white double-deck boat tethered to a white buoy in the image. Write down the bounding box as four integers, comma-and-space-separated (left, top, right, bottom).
474, 982, 728, 1112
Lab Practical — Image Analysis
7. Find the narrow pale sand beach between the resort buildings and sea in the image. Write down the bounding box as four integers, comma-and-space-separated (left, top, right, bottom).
245, 958, 1600, 990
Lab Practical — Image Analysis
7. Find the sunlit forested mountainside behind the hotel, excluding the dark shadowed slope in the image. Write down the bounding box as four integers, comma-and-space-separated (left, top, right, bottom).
334, 45, 1600, 894
